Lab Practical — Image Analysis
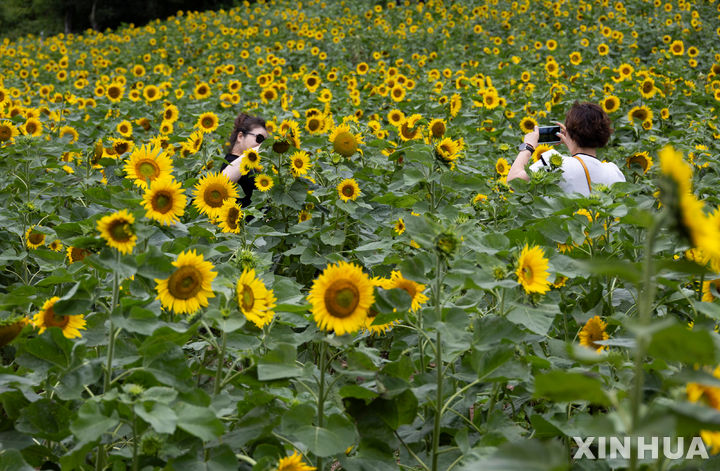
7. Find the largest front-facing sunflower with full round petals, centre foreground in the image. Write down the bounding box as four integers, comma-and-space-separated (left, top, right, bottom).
307, 262, 375, 335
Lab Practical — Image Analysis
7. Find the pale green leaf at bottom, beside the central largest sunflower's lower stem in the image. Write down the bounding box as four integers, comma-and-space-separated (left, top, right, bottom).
293, 414, 357, 457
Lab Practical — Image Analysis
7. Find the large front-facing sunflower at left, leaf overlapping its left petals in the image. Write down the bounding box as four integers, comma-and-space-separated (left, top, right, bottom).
155, 250, 217, 314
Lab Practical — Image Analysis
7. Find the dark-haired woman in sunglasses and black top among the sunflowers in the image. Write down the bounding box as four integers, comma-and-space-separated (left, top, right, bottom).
220, 113, 268, 208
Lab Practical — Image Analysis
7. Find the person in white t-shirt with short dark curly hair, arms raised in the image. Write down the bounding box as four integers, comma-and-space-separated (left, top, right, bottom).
507, 102, 625, 196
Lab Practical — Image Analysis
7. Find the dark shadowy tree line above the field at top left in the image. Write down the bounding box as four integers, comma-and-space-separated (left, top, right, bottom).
0, 0, 239, 38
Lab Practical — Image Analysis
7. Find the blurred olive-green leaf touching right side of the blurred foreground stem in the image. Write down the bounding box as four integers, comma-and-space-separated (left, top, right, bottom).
648, 325, 717, 365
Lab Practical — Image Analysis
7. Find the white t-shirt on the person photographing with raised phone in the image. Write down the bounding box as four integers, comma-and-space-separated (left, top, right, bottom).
530, 149, 625, 196
